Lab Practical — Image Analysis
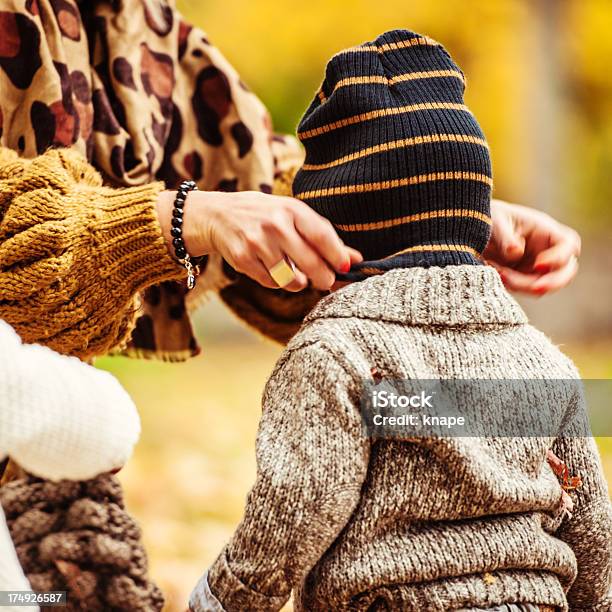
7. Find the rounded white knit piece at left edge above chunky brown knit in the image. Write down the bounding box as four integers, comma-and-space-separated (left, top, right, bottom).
0, 321, 140, 480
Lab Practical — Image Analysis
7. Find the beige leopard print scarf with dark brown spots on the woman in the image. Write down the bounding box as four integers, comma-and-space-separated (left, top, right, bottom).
0, 0, 301, 360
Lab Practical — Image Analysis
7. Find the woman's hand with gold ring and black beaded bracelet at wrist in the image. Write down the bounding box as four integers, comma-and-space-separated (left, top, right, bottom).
158, 191, 362, 291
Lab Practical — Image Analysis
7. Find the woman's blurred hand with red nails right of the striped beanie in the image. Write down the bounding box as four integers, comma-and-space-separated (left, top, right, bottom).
484, 200, 580, 295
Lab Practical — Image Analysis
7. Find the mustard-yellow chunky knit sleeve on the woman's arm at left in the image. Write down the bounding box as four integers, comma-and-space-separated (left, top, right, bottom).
0, 148, 183, 358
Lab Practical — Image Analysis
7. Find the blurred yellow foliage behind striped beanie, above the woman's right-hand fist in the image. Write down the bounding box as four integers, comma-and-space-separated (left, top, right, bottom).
178, 0, 612, 229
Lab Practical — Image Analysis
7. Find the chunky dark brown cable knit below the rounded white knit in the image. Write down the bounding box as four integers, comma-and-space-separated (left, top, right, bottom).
0, 474, 163, 612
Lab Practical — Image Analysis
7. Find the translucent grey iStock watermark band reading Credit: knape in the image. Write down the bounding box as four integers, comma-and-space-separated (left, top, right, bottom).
360, 376, 612, 439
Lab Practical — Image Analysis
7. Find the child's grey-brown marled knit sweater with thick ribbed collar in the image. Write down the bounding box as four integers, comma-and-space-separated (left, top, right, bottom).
196, 266, 612, 612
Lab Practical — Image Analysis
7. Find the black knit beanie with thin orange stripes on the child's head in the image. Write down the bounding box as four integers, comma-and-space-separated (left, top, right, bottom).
293, 30, 492, 280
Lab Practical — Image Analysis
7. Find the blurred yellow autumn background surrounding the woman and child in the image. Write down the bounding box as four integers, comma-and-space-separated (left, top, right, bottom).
99, 0, 612, 611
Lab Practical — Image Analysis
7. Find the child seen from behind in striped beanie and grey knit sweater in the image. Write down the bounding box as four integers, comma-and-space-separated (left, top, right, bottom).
191, 31, 612, 612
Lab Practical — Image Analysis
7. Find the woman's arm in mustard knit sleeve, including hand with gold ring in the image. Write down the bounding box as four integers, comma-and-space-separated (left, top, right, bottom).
0, 149, 359, 358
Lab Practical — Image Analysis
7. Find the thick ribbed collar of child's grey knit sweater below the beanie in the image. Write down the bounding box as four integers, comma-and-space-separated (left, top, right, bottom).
306, 265, 527, 327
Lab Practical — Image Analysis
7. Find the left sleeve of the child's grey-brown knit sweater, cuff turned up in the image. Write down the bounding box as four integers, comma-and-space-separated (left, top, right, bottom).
190, 344, 369, 612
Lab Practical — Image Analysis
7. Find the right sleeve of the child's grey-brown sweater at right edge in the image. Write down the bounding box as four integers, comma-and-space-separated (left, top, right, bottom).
552, 395, 612, 612
